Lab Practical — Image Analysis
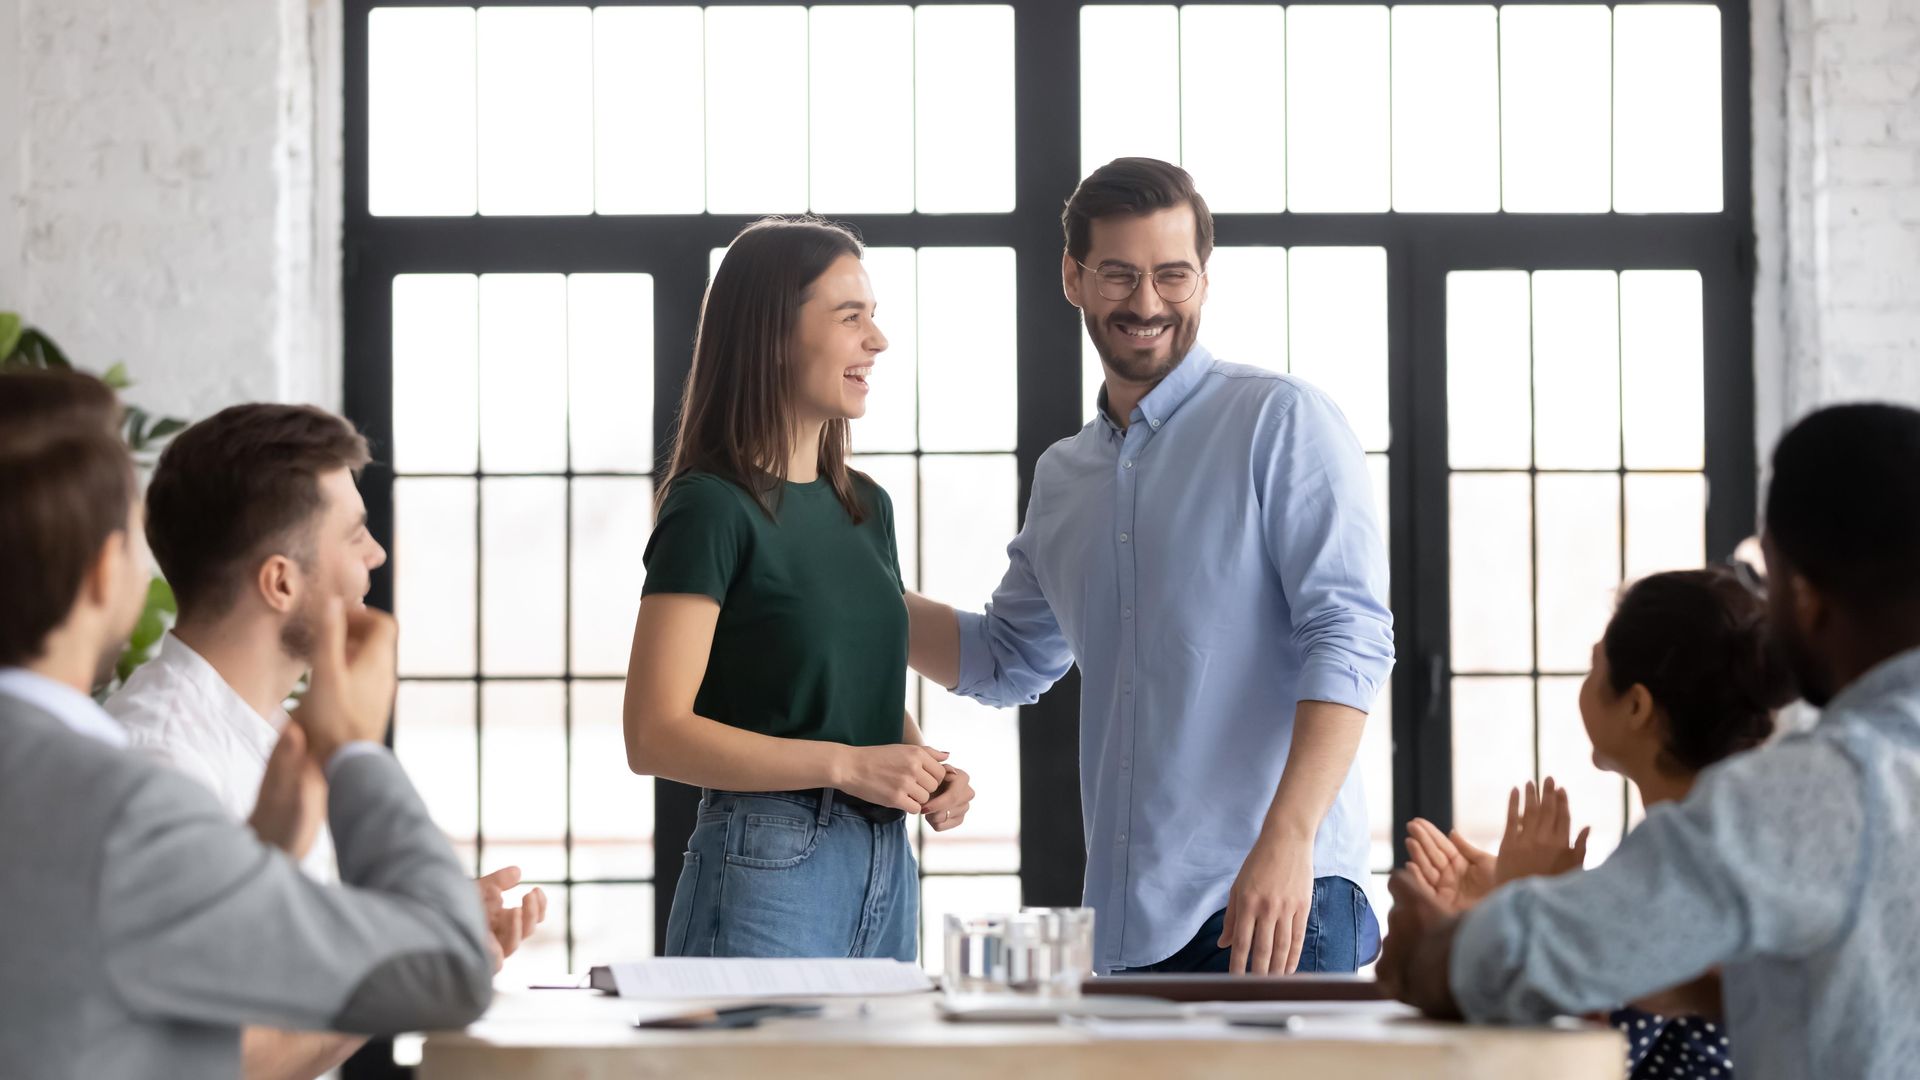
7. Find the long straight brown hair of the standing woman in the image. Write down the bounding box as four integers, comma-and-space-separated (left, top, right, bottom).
655, 215, 866, 523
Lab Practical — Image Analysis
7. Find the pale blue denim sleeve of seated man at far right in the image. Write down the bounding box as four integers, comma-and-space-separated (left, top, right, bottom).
1450, 740, 1866, 1022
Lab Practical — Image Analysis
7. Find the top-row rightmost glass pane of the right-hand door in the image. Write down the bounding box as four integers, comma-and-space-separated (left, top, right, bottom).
1620, 271, 1707, 469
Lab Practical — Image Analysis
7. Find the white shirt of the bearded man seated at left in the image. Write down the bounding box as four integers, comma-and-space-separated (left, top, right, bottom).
106, 632, 340, 882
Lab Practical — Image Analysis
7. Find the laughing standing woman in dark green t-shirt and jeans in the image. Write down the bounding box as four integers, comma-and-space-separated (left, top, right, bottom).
624, 219, 973, 961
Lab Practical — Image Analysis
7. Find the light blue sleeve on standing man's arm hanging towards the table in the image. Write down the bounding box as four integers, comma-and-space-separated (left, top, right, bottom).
1256, 386, 1394, 713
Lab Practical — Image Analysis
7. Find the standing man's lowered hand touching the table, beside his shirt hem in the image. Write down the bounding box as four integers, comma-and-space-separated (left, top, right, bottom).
1219, 834, 1313, 974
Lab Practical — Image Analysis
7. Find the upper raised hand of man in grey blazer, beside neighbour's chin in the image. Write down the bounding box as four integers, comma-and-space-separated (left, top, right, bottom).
294, 600, 399, 767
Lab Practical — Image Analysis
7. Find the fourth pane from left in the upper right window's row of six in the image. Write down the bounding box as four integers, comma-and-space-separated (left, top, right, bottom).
1394, 4, 1500, 213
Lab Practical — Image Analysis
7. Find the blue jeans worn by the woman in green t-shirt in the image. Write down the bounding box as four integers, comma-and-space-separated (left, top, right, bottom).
666, 780, 920, 961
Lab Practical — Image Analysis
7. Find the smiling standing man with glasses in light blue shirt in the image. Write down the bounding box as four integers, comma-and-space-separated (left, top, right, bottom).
908, 158, 1394, 974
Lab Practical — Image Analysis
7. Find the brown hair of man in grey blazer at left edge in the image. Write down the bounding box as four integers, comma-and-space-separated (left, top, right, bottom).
0, 371, 134, 667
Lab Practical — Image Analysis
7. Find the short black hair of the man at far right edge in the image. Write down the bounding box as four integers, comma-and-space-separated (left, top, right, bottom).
1766, 404, 1920, 626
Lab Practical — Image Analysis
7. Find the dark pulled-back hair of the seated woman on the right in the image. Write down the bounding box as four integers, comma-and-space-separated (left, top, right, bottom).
1601, 567, 1793, 773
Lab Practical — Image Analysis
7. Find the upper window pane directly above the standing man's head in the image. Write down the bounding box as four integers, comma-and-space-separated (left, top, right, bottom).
1081, 4, 1181, 177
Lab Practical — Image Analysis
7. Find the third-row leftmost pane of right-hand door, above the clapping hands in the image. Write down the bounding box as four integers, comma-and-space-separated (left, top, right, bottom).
1453, 672, 1534, 851
